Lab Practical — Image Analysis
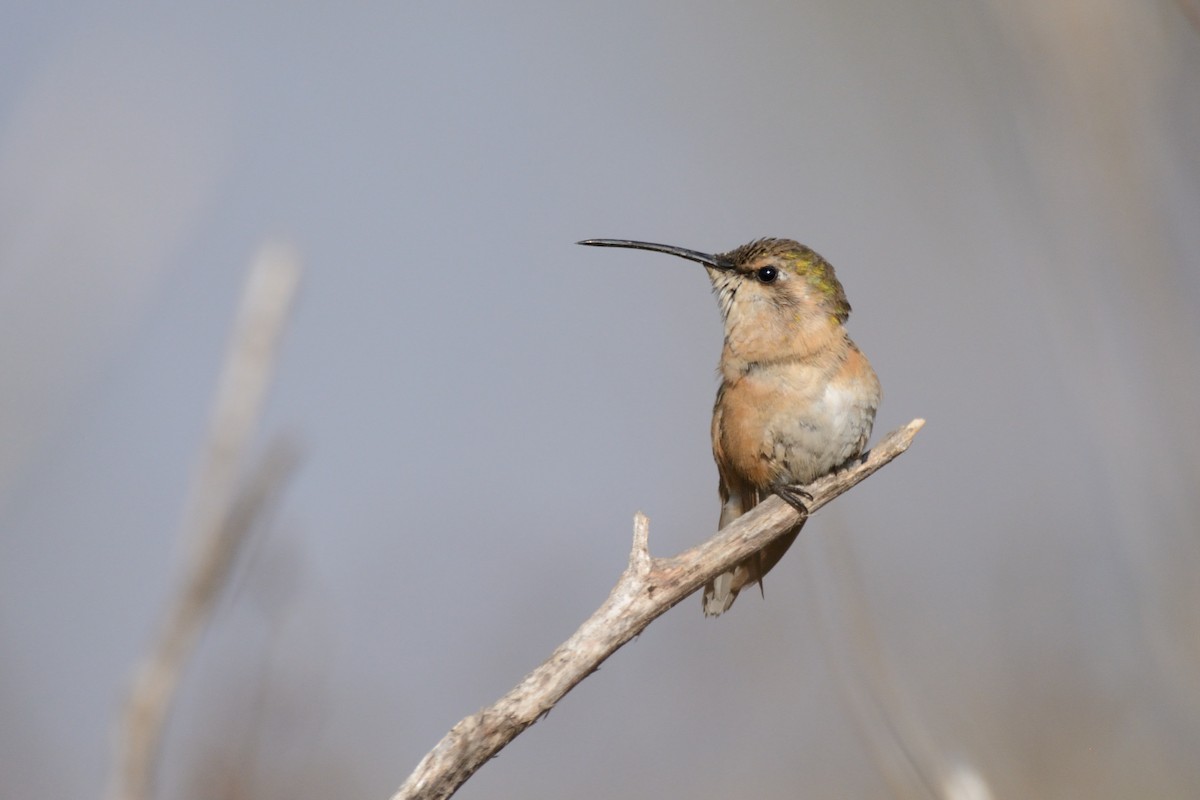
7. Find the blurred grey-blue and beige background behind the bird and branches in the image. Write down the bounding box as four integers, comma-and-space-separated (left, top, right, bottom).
0, 0, 1200, 800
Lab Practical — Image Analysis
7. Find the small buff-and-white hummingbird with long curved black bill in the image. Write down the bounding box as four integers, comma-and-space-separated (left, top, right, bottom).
578, 239, 882, 616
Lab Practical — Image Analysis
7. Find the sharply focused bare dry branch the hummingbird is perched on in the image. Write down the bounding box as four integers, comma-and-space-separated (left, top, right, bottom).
392, 420, 925, 800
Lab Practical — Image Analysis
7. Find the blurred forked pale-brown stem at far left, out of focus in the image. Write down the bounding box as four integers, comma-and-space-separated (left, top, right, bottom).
108, 246, 300, 800
